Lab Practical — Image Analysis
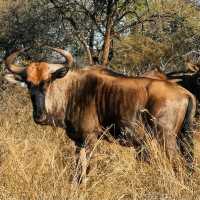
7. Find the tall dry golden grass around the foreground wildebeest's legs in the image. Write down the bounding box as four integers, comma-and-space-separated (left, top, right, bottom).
0, 80, 200, 200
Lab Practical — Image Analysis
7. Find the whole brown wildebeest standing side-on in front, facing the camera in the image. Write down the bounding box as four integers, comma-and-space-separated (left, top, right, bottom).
5, 48, 196, 180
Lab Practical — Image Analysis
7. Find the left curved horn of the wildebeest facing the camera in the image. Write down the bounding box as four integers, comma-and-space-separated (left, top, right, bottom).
4, 48, 25, 74
